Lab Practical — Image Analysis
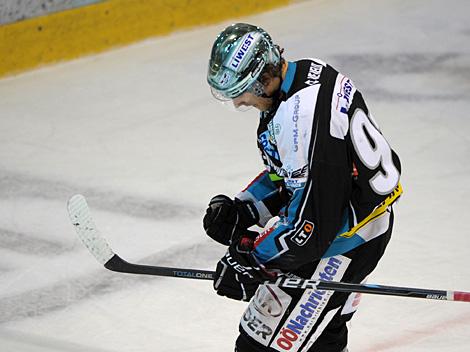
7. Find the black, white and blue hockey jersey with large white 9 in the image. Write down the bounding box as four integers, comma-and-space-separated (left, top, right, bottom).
237, 59, 402, 271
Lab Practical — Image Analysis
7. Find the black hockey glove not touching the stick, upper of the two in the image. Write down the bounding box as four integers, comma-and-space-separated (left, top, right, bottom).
203, 194, 259, 246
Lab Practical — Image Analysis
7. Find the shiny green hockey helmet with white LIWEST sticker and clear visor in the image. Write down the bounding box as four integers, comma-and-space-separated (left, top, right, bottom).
207, 23, 281, 100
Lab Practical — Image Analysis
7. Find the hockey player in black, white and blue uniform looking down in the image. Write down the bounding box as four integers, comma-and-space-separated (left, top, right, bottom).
203, 23, 402, 352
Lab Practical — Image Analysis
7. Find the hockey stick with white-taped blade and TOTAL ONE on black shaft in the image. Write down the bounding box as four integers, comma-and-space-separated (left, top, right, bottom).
67, 194, 470, 302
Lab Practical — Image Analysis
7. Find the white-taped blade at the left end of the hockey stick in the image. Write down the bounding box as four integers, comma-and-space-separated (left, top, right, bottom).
67, 194, 114, 265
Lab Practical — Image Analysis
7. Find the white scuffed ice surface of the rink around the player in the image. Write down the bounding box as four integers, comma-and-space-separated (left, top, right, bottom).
0, 0, 470, 352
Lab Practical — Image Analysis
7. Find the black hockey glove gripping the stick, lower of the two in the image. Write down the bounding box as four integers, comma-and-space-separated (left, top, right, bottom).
214, 231, 276, 301
